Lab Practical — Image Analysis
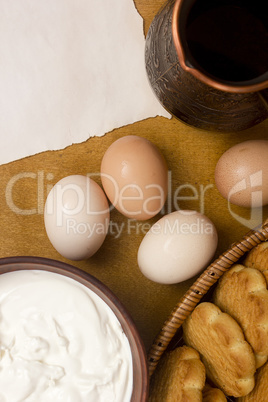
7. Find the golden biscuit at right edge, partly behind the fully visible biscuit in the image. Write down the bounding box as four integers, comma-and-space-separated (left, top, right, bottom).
213, 264, 268, 368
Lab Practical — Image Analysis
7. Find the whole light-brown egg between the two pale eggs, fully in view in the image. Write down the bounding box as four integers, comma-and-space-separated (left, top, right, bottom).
101, 135, 168, 220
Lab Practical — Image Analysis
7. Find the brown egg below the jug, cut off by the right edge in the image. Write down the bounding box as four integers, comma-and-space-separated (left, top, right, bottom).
215, 140, 268, 208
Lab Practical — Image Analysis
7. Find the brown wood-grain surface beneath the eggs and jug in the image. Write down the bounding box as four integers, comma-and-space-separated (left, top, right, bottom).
0, 0, 268, 349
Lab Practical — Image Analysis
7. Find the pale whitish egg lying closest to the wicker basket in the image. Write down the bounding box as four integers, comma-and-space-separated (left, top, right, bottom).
138, 210, 218, 284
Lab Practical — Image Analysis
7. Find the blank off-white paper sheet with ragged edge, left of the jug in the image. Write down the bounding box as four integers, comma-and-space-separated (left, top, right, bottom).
0, 0, 170, 164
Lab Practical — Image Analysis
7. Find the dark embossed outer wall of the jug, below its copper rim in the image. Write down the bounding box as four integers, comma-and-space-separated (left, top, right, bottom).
145, 0, 268, 132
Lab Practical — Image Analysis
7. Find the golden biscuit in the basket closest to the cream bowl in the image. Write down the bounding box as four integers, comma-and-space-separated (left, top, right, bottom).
149, 346, 206, 402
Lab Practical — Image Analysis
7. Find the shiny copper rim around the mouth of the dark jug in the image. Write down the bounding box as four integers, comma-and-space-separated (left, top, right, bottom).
171, 0, 268, 93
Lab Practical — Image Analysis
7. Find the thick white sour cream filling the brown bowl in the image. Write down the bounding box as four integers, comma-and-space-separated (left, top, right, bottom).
0, 270, 133, 402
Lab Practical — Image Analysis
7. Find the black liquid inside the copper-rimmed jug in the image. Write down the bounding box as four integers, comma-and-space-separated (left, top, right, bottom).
186, 0, 268, 82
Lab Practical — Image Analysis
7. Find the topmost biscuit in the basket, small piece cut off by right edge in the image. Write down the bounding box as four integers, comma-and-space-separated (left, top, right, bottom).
243, 241, 268, 283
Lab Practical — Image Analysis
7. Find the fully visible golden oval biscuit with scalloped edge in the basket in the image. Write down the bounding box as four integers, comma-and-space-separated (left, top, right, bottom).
183, 302, 256, 397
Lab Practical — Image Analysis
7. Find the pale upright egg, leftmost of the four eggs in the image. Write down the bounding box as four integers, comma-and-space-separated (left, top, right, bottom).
44, 175, 110, 260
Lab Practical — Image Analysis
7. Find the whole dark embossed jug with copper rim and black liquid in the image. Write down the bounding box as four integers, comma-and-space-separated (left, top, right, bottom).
145, 0, 268, 132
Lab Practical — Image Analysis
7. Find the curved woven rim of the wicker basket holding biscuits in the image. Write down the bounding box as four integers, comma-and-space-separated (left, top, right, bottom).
148, 220, 268, 375
